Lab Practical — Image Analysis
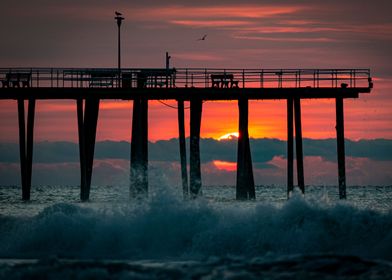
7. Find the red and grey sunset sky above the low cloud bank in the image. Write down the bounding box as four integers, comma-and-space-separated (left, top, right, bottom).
0, 0, 392, 187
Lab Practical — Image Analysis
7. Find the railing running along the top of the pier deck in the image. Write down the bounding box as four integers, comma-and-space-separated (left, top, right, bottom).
0, 68, 373, 88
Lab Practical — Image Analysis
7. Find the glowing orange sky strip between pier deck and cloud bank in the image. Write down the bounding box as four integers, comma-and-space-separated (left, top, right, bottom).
0, 87, 392, 142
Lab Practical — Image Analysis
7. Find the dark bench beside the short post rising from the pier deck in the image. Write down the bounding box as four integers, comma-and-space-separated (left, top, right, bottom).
136, 68, 177, 88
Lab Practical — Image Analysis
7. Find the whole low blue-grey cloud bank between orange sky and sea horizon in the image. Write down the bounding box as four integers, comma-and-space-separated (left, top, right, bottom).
0, 139, 392, 186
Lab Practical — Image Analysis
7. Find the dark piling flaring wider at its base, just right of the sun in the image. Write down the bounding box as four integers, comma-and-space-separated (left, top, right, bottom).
236, 98, 256, 200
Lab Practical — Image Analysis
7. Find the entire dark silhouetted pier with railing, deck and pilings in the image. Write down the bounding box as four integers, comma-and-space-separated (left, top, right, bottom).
0, 67, 373, 201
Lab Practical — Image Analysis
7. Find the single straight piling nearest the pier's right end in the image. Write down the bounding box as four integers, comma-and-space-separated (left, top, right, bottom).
336, 97, 346, 199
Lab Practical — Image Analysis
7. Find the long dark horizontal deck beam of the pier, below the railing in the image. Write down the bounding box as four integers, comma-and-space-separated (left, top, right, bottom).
0, 88, 364, 101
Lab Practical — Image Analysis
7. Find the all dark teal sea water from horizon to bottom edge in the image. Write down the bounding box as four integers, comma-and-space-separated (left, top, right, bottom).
0, 185, 392, 279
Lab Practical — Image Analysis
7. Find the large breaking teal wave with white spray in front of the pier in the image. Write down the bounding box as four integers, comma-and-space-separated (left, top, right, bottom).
0, 194, 392, 261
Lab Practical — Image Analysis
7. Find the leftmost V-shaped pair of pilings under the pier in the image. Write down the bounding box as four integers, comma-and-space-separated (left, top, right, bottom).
18, 99, 35, 200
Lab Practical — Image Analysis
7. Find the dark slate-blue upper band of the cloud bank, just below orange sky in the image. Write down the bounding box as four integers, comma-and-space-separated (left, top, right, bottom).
0, 138, 392, 164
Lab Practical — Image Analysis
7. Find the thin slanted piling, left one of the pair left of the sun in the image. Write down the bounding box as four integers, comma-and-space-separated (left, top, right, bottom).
177, 100, 189, 199
